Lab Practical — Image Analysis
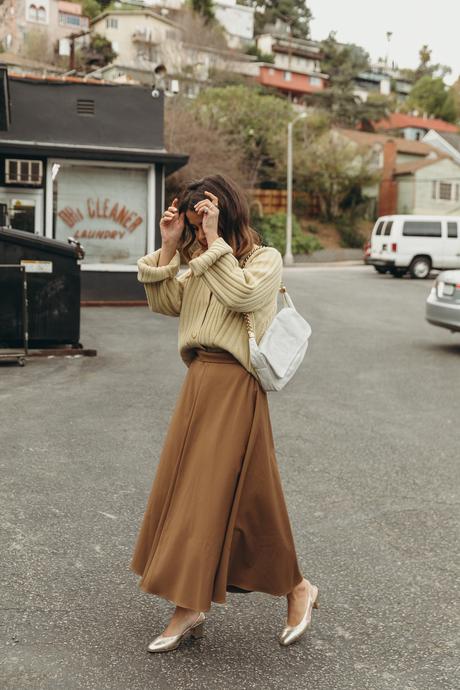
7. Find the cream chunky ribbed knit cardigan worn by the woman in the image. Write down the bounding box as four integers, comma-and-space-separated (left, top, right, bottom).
137, 237, 283, 376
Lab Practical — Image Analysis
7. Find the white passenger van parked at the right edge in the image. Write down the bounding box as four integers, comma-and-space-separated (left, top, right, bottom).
364, 215, 460, 278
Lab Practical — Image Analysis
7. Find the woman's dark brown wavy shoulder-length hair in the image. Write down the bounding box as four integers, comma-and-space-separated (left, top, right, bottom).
177, 175, 262, 261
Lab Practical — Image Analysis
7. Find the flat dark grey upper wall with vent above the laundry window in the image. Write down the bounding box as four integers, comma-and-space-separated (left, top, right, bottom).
0, 76, 188, 172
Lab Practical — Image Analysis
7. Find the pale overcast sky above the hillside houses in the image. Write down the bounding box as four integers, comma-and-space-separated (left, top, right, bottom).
307, 0, 460, 83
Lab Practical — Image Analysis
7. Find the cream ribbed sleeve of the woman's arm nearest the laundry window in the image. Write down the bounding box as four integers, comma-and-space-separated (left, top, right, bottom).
137, 249, 190, 316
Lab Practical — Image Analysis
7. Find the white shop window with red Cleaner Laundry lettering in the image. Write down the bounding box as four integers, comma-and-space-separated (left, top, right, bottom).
53, 162, 147, 265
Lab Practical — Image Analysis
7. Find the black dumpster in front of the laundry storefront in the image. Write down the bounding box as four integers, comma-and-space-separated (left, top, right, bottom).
0, 228, 84, 348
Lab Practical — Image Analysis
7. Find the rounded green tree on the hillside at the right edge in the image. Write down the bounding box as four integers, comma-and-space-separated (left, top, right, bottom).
406, 74, 459, 122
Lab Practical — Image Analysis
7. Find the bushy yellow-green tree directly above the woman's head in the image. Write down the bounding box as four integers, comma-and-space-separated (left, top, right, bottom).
193, 85, 293, 186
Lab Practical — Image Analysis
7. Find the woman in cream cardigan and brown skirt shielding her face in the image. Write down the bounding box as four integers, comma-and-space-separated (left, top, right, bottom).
130, 175, 318, 652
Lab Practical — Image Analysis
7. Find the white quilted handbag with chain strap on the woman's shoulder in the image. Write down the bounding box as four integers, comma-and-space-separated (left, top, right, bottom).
242, 250, 311, 391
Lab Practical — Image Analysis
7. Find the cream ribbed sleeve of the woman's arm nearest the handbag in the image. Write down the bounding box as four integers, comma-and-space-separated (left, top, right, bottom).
189, 237, 283, 312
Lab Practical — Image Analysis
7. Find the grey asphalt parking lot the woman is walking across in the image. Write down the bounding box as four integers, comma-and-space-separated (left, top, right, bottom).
0, 266, 460, 690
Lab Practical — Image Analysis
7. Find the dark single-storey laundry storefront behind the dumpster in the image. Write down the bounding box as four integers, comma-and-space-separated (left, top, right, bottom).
0, 76, 187, 301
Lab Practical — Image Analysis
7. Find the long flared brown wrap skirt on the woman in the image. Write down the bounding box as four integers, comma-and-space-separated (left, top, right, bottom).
130, 350, 303, 611
